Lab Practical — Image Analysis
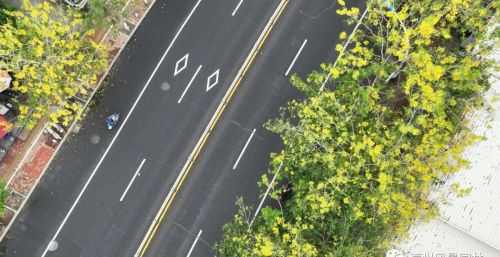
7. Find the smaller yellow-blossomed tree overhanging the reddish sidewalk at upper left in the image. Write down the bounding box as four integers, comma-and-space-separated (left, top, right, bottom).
0, 0, 106, 127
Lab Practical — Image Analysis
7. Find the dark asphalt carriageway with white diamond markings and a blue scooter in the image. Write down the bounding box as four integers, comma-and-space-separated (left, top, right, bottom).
2, 0, 277, 257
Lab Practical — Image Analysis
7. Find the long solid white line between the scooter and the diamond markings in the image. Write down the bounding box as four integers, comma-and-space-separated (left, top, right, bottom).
42, 0, 202, 254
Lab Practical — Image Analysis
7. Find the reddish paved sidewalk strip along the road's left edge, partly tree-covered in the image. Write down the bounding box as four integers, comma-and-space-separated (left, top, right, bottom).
0, 0, 154, 238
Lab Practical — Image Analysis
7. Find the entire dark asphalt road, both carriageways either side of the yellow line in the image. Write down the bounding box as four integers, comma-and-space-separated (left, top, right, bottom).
0, 0, 360, 257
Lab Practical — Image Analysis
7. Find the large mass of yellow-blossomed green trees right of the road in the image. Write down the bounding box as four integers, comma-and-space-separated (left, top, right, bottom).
215, 0, 498, 257
